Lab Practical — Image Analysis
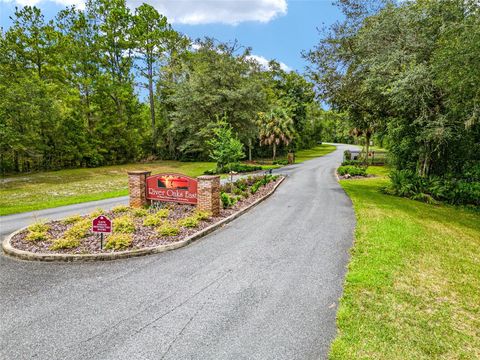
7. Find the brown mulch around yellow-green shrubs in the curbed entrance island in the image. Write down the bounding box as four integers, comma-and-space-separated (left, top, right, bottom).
10, 179, 279, 254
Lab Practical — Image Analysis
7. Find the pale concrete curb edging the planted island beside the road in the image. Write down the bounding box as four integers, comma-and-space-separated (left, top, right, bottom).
2, 176, 286, 262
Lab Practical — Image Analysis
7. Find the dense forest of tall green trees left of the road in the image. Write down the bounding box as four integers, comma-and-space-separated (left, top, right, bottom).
0, 0, 348, 172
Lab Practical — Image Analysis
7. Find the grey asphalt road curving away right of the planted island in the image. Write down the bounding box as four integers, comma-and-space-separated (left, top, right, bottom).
0, 145, 355, 360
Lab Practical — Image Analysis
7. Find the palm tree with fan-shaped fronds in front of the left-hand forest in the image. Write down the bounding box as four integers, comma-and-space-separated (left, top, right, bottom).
258, 107, 294, 161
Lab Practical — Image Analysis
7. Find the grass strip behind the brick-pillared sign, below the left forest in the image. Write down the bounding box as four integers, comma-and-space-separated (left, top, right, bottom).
0, 161, 215, 215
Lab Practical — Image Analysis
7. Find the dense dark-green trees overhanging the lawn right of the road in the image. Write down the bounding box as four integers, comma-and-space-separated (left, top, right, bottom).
304, 0, 480, 205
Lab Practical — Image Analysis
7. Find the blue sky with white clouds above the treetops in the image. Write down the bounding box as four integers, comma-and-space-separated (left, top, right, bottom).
0, 0, 341, 72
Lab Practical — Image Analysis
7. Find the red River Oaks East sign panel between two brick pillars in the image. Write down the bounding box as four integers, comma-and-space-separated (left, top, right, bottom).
147, 174, 197, 204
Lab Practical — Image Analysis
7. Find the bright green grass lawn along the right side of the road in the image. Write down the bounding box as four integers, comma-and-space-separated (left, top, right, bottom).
330, 167, 480, 360
